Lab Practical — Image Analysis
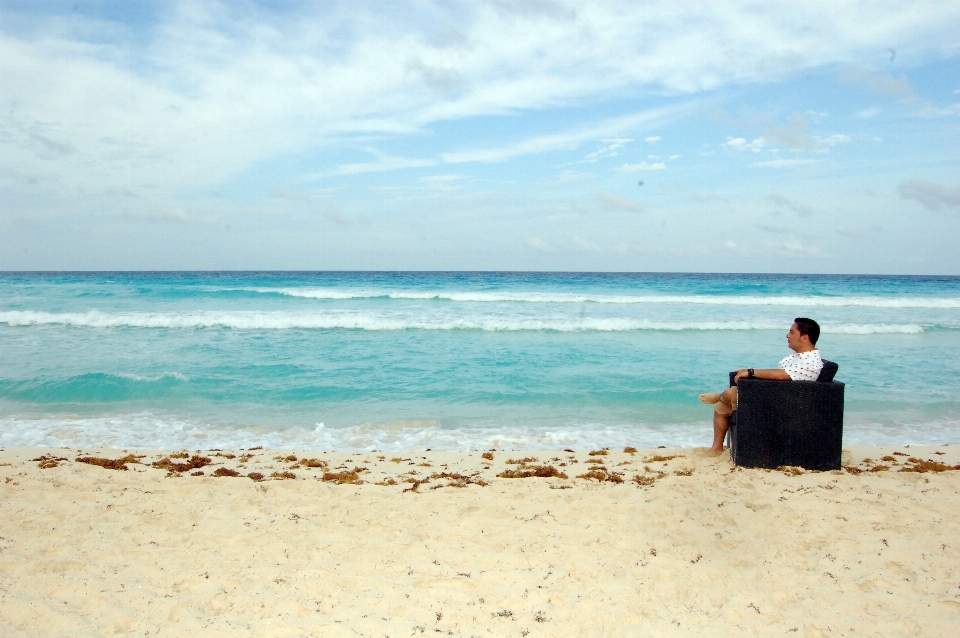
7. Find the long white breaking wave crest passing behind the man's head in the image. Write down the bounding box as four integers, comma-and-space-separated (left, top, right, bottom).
0, 310, 924, 335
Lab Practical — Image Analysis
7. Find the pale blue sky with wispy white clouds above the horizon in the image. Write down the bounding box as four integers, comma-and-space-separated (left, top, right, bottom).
0, 0, 960, 275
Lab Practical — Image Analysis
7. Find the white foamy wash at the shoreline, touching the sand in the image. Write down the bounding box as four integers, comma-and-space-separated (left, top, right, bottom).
0, 412, 960, 452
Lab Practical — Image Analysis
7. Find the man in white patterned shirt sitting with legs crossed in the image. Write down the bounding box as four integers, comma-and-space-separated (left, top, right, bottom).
700, 317, 823, 456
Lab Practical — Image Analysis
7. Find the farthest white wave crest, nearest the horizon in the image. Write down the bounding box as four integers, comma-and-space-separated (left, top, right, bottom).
244, 288, 960, 309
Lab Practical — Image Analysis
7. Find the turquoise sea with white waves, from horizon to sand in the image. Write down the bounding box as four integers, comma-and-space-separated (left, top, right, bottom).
0, 272, 960, 451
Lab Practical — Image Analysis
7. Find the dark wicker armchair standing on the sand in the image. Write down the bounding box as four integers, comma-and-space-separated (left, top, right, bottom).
729, 361, 844, 470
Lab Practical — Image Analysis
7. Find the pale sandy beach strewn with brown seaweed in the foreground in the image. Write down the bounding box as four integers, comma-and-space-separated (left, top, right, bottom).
0, 446, 960, 637
